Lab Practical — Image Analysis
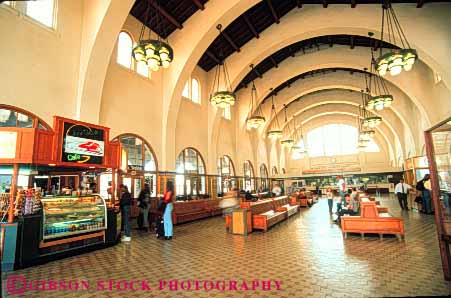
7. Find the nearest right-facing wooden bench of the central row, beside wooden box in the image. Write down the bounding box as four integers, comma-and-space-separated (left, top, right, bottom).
250, 200, 288, 232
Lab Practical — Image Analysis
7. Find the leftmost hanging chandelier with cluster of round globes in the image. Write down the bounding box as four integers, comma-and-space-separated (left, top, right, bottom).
132, 0, 174, 71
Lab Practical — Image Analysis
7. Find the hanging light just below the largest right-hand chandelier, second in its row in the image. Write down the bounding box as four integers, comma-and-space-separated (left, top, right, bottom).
365, 48, 393, 111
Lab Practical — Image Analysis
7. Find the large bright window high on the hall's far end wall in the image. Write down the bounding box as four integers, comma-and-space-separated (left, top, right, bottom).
307, 124, 358, 157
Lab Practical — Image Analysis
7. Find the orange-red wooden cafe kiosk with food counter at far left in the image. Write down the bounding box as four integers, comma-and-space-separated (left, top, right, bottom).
0, 105, 120, 270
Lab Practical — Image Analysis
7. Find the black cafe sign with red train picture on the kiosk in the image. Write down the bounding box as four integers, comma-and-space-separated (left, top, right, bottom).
62, 122, 105, 164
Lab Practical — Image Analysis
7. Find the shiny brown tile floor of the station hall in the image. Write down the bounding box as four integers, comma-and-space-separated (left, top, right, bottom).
2, 194, 451, 298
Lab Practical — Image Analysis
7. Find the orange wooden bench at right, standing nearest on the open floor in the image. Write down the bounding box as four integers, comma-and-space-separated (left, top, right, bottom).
341, 201, 404, 239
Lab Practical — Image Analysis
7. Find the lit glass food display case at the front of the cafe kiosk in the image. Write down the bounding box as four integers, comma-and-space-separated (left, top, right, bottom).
41, 195, 107, 240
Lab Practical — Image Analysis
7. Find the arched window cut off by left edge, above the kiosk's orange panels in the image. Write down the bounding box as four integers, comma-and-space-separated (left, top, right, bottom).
0, 104, 52, 130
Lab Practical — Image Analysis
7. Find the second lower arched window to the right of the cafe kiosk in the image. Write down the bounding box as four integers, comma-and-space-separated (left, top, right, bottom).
175, 148, 206, 199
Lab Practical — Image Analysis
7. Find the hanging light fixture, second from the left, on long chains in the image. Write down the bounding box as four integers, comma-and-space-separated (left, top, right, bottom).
210, 24, 236, 109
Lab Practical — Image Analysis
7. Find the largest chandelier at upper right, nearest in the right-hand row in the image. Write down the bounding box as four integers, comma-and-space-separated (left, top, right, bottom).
376, 0, 418, 76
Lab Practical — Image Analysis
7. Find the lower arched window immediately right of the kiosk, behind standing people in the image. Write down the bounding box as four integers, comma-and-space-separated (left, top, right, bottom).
112, 134, 158, 197
